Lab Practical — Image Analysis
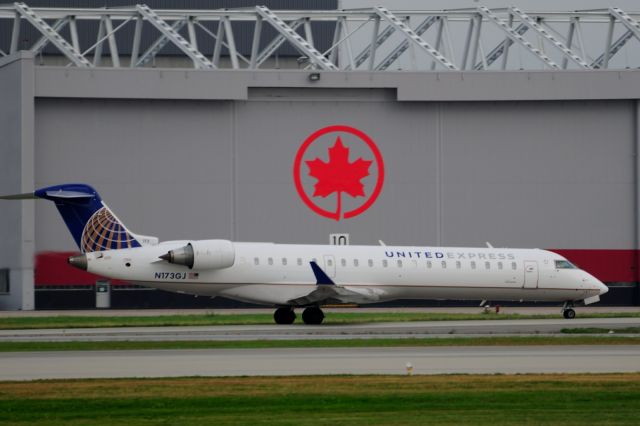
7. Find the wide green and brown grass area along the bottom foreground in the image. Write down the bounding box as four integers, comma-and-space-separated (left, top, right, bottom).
0, 374, 640, 426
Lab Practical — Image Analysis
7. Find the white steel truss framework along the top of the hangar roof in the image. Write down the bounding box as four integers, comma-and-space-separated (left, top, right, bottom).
0, 2, 640, 71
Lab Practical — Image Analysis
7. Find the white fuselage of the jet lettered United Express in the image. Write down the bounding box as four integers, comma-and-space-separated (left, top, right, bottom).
82, 241, 607, 305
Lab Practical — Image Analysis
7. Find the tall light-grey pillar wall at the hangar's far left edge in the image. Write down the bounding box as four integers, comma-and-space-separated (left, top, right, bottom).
0, 56, 34, 310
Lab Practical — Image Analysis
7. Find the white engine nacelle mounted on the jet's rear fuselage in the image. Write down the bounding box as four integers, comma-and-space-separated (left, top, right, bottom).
160, 240, 236, 269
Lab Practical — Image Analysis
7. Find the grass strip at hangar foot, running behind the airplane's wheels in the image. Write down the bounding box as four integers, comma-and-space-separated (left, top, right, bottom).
0, 312, 640, 330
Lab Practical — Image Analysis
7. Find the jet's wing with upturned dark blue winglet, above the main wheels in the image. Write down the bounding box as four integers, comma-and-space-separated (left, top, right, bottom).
287, 262, 384, 306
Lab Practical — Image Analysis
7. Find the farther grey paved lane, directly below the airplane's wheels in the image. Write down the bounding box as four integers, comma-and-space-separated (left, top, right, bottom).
0, 318, 640, 341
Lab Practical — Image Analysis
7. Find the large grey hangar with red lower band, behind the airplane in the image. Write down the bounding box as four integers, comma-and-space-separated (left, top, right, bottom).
0, 0, 640, 310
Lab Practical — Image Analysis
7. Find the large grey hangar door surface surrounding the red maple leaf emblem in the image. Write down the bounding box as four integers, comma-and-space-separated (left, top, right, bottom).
35, 95, 635, 250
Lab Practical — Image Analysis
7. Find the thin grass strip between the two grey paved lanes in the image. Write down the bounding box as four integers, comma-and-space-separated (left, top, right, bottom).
0, 336, 640, 352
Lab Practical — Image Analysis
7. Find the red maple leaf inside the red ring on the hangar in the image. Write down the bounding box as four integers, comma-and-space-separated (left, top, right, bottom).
306, 136, 372, 220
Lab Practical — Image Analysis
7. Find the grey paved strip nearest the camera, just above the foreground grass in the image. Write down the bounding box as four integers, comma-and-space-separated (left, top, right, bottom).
0, 345, 640, 380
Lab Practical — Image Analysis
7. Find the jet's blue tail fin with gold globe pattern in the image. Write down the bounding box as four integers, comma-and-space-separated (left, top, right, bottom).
33, 183, 141, 253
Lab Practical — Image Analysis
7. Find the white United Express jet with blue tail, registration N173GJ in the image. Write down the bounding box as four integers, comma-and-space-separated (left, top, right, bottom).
0, 183, 608, 324
